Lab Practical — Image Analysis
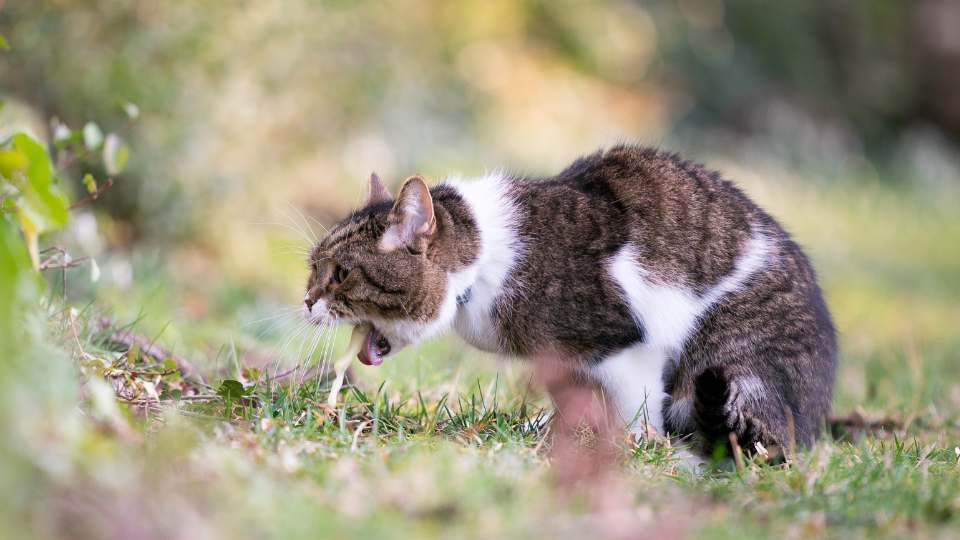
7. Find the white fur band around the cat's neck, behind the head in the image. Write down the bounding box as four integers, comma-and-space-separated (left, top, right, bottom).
446, 174, 523, 352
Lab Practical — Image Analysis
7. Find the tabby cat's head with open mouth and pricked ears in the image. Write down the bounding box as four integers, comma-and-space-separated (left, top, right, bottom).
304, 174, 456, 365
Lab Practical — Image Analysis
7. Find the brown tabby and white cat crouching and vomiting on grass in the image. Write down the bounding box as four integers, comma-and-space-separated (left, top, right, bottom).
304, 145, 837, 456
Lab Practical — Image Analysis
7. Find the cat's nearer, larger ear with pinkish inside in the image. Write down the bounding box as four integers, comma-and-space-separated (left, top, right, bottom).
379, 176, 437, 253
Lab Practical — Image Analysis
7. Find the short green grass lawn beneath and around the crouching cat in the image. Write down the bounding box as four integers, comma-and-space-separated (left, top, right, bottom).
0, 172, 960, 538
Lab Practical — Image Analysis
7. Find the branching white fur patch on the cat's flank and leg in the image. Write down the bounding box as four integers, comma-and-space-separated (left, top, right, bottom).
590, 233, 772, 433
